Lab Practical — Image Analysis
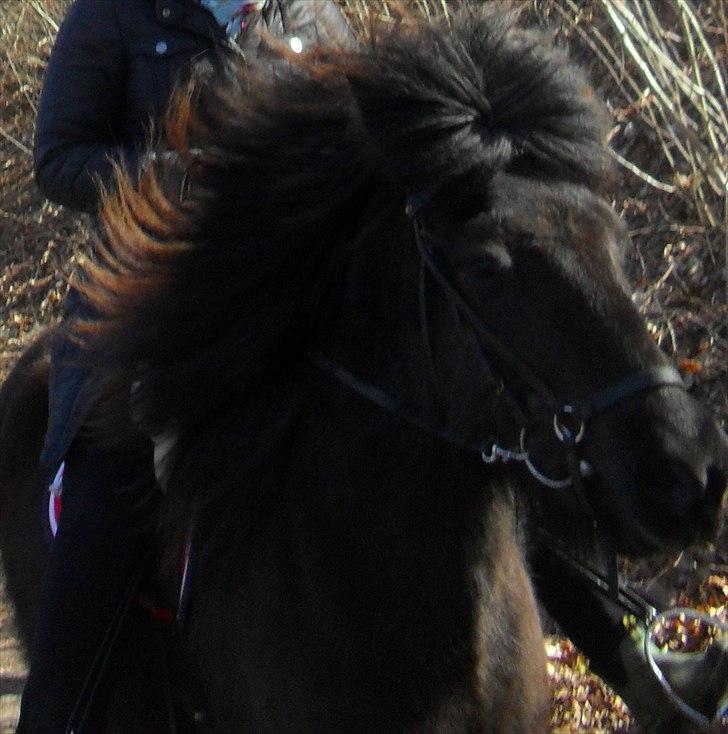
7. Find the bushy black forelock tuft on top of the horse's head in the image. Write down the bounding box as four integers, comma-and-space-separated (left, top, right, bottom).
346, 8, 611, 208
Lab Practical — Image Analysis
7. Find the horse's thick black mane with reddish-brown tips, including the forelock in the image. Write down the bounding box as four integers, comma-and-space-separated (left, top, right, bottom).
84, 5, 609, 468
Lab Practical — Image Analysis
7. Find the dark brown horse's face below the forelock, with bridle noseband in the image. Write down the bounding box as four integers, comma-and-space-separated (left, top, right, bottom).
410, 177, 728, 554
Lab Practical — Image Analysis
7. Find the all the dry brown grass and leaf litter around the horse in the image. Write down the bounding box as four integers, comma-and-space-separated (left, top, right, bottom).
0, 0, 728, 733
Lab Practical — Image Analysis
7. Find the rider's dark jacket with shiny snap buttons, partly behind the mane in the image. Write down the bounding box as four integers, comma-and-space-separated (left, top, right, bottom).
35, 0, 352, 471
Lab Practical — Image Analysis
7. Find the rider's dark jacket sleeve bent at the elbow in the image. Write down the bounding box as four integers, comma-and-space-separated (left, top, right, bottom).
34, 0, 140, 211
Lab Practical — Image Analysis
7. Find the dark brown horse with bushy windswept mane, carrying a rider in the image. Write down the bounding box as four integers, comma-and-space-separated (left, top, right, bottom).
0, 7, 728, 734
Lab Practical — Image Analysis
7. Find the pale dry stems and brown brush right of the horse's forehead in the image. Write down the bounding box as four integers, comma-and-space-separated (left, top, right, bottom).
538, 0, 728, 421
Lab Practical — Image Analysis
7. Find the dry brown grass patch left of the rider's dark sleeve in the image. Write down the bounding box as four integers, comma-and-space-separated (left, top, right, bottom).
0, 0, 90, 375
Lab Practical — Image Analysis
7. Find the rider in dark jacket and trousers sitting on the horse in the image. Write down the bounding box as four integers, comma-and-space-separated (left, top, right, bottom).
18, 0, 351, 732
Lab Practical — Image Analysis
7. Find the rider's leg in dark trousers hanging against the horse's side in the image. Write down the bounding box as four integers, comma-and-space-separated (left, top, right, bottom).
18, 439, 157, 732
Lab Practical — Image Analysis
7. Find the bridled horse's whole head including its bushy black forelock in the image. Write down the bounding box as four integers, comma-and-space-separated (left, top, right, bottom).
308, 7, 728, 554
